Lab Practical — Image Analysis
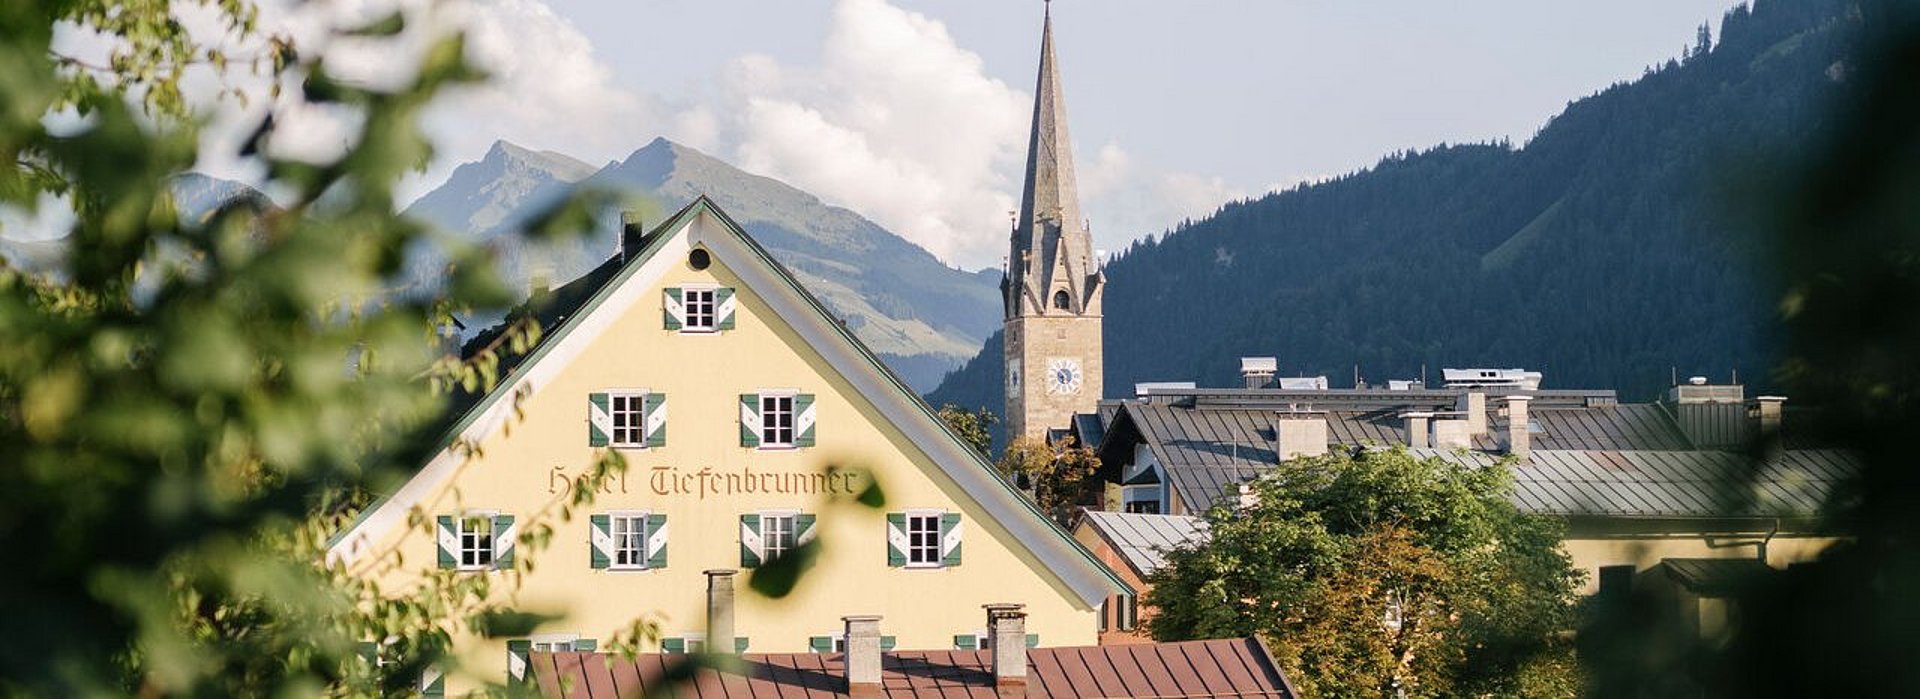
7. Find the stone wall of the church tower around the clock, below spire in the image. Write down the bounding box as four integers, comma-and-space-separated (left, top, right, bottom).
1006, 315, 1106, 438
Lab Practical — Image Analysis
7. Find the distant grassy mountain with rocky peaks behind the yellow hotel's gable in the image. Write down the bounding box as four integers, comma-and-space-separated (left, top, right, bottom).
407, 138, 998, 390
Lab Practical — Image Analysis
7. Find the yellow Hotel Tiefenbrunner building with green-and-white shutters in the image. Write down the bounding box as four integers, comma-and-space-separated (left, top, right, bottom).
330, 198, 1127, 691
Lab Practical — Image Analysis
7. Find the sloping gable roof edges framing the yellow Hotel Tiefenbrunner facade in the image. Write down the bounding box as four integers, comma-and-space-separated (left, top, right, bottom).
328, 194, 1133, 605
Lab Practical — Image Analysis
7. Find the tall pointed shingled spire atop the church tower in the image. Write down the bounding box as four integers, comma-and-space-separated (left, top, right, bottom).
1004, 4, 1098, 317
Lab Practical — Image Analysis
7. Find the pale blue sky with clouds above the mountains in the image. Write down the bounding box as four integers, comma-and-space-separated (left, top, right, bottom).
22, 0, 1734, 269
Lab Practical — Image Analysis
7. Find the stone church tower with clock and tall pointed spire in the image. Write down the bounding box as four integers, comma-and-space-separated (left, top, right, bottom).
1000, 4, 1106, 438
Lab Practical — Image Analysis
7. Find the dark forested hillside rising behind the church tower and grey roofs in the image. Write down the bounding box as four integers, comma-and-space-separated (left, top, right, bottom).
929, 0, 1859, 420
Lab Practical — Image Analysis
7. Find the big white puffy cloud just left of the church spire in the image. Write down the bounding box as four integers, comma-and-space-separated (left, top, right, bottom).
722, 0, 1031, 265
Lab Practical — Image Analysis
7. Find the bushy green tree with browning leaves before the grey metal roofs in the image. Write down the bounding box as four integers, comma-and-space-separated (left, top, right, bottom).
1144, 449, 1582, 697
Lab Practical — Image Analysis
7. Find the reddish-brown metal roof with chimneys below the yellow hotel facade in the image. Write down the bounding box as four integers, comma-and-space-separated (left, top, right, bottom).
532, 638, 1298, 699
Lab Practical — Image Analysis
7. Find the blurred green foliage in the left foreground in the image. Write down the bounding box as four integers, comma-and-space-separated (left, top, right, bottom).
0, 0, 624, 697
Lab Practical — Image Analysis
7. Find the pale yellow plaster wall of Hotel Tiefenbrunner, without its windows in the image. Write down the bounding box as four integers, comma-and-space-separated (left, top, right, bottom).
341, 217, 1098, 691
